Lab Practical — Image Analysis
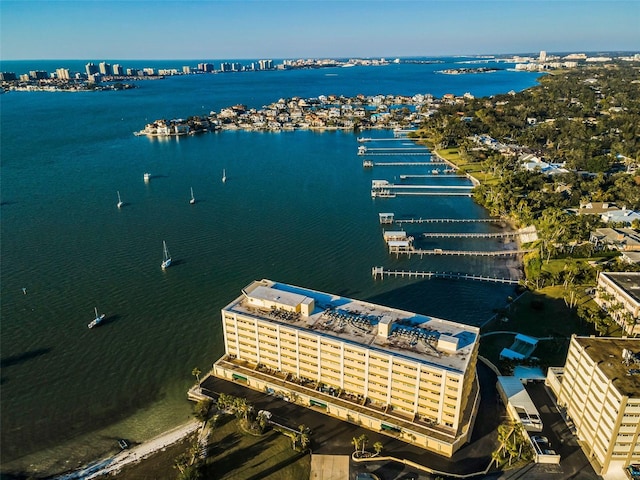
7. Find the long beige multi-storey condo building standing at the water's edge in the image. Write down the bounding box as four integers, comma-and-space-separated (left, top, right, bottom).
214, 280, 480, 456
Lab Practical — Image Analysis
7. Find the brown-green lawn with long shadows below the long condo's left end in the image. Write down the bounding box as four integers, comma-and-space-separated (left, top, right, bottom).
203, 417, 311, 480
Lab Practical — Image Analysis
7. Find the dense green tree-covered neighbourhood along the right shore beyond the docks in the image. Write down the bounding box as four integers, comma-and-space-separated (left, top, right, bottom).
420, 65, 640, 274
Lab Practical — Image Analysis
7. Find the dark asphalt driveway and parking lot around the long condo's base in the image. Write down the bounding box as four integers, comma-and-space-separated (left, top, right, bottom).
202, 362, 600, 480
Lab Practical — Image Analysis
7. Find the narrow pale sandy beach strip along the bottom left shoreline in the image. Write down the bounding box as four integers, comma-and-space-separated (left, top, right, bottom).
54, 420, 201, 480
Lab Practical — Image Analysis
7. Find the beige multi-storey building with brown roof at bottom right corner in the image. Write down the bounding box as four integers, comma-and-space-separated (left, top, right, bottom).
555, 335, 640, 475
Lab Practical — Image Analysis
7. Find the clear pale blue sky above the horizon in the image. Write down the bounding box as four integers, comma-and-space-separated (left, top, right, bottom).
0, 0, 640, 60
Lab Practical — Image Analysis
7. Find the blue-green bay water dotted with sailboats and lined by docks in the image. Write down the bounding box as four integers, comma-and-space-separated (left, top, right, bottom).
0, 58, 536, 474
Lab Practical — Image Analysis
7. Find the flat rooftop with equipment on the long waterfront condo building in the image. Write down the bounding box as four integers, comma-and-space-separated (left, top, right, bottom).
224, 280, 479, 372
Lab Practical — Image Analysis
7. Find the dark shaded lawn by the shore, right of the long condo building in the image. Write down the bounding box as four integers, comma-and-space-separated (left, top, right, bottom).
480, 286, 604, 367
